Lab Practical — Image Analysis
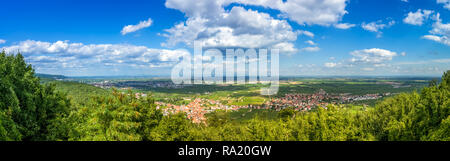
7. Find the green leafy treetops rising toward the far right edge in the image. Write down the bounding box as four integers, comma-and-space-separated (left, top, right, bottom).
371, 71, 450, 140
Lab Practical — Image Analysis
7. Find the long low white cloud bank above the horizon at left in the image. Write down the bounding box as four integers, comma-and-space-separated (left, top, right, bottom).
2, 40, 189, 70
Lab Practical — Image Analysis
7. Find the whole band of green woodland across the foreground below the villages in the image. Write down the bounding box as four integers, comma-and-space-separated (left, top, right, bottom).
0, 52, 450, 141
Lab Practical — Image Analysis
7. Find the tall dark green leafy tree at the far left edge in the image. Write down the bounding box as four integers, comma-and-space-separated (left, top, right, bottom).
0, 51, 70, 140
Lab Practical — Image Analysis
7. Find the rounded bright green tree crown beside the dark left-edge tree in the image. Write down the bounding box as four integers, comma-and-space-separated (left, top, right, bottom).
69, 90, 162, 141
